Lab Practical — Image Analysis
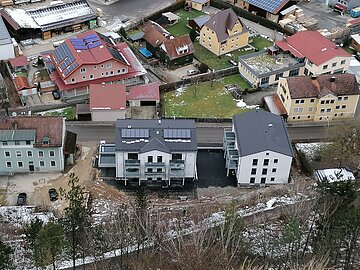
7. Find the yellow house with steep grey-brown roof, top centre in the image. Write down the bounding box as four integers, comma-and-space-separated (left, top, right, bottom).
199, 8, 249, 56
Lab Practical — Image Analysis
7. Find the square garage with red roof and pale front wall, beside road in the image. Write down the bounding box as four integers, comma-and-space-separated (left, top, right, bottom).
89, 83, 126, 121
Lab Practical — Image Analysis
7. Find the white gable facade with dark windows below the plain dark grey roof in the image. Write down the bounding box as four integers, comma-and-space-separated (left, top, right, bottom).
236, 151, 292, 185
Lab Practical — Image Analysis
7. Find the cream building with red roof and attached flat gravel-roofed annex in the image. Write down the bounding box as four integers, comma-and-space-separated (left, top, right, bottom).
239, 31, 351, 87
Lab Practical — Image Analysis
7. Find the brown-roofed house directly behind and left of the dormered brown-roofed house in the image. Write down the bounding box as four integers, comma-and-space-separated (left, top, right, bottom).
142, 21, 172, 58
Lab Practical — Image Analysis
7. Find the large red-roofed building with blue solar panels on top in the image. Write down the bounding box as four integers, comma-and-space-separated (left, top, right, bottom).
44, 30, 148, 99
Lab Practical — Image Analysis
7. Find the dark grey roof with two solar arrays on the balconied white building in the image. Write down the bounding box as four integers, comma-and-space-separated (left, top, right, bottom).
115, 119, 197, 153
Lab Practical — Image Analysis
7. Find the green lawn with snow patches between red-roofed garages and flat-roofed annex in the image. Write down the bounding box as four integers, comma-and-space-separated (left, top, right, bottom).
161, 75, 249, 118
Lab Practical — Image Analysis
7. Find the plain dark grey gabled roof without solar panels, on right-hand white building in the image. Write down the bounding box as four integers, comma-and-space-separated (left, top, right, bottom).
233, 110, 293, 156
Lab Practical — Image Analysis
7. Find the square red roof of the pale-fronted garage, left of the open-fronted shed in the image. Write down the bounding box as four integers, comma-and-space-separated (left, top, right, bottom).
90, 84, 126, 111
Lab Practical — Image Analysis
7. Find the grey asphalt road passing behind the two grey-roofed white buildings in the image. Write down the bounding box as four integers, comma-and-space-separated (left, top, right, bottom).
66, 122, 327, 146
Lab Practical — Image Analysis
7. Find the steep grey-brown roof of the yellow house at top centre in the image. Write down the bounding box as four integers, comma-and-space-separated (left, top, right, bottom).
204, 8, 248, 42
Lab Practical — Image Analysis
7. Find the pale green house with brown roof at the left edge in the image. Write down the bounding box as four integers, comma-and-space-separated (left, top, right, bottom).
0, 116, 76, 175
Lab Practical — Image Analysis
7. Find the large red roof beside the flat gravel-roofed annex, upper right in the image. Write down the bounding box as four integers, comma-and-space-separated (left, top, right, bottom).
275, 31, 351, 65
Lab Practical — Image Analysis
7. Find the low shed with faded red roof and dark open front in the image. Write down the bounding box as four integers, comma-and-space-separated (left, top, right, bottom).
127, 82, 160, 107
